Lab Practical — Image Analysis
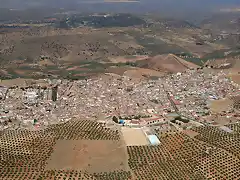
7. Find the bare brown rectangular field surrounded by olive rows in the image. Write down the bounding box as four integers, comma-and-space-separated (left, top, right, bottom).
46, 140, 129, 173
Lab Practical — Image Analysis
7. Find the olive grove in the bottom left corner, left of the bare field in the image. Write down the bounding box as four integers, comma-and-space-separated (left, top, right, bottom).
0, 131, 55, 179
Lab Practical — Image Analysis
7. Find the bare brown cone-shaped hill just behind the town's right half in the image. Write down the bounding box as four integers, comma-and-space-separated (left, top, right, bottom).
142, 54, 198, 73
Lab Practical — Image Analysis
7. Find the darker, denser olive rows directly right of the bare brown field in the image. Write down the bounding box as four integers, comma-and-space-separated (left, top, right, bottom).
128, 133, 204, 180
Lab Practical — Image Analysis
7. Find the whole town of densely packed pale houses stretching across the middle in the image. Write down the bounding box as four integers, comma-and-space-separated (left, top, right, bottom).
0, 69, 239, 129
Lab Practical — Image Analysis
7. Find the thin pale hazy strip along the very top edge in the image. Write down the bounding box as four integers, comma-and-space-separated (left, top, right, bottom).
0, 0, 240, 11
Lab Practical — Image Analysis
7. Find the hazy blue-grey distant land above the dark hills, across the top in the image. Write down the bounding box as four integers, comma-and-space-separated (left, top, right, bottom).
0, 0, 240, 24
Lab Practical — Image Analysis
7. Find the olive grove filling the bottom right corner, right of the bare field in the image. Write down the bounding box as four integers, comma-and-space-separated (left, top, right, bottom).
128, 133, 240, 180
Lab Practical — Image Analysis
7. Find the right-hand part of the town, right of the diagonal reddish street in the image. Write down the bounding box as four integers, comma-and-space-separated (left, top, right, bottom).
166, 71, 239, 119
